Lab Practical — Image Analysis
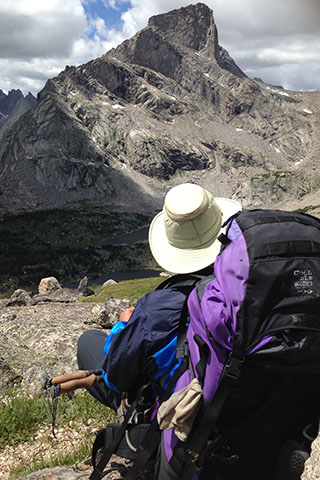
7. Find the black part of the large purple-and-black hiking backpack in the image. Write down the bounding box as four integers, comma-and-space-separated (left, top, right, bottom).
164, 210, 320, 480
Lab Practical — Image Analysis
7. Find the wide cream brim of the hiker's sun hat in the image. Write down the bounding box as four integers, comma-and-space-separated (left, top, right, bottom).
149, 197, 242, 273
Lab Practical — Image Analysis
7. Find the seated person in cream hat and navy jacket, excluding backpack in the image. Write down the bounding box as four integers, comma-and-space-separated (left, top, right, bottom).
77, 184, 241, 411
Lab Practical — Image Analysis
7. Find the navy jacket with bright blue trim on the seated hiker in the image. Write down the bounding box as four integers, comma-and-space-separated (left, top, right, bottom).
102, 272, 213, 393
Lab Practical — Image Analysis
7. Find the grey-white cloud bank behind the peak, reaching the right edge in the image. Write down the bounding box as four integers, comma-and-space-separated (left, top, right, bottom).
113, 0, 320, 90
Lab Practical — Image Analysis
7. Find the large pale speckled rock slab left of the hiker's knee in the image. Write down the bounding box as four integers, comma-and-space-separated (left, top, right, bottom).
0, 277, 130, 395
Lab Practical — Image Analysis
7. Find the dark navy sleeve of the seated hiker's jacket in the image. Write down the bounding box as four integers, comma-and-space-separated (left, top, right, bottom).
103, 289, 186, 392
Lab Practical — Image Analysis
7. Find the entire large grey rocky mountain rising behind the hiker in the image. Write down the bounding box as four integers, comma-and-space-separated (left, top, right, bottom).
0, 3, 320, 218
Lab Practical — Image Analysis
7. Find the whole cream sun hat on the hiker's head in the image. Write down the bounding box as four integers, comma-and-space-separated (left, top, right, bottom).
149, 183, 242, 273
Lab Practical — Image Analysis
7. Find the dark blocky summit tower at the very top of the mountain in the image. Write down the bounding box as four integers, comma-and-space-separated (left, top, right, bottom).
148, 3, 219, 62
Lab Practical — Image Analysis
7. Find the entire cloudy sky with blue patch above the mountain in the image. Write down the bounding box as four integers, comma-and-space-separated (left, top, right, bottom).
0, 0, 320, 94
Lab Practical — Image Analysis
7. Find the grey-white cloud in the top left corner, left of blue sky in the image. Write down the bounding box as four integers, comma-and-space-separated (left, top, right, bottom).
0, 0, 88, 94
